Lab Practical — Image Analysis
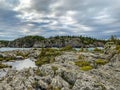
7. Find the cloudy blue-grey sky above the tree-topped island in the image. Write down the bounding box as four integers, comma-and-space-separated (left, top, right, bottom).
0, 0, 120, 40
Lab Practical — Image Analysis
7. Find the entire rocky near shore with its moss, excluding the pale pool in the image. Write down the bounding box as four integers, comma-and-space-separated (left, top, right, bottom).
0, 46, 120, 90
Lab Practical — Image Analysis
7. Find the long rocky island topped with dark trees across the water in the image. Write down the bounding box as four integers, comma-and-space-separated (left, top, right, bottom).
7, 36, 106, 48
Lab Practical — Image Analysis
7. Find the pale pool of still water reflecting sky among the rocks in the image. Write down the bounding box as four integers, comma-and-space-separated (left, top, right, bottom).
4, 59, 36, 70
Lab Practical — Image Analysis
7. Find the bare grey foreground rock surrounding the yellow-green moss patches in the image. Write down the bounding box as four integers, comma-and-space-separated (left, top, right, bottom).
0, 51, 120, 90
